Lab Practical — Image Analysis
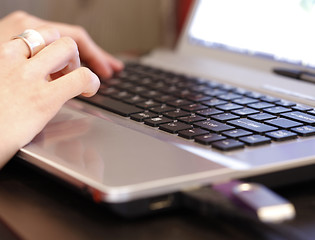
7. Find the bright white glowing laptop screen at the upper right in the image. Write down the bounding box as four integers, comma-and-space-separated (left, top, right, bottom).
188, 0, 315, 67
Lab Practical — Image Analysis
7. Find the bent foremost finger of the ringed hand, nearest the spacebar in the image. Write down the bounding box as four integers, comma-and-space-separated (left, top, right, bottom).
49, 67, 100, 103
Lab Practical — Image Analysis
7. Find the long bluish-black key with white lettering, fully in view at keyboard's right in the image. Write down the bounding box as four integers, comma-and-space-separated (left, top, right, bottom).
227, 118, 277, 133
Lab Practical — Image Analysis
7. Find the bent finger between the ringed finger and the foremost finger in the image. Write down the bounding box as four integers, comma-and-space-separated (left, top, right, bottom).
29, 37, 80, 79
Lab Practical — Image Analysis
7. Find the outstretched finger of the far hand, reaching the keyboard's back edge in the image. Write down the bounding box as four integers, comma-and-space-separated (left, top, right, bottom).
47, 23, 124, 77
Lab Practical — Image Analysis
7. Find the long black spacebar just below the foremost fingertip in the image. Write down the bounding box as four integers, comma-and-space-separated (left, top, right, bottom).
79, 95, 143, 117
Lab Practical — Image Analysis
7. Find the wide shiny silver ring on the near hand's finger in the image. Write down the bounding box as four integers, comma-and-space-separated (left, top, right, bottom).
12, 29, 46, 58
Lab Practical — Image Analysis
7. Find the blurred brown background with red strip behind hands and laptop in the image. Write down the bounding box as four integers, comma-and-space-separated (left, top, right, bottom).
0, 0, 192, 55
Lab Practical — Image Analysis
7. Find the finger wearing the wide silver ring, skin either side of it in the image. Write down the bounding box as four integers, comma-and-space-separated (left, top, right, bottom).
7, 26, 60, 59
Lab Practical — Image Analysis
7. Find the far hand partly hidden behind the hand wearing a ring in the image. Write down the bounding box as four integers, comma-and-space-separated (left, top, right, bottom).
0, 11, 123, 78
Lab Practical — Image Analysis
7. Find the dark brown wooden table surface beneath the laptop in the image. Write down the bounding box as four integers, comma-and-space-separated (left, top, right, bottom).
0, 159, 315, 240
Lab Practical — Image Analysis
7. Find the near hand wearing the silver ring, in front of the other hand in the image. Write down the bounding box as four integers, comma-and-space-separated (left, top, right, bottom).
0, 27, 100, 167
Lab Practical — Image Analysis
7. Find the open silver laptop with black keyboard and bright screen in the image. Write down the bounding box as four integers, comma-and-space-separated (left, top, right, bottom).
18, 0, 315, 216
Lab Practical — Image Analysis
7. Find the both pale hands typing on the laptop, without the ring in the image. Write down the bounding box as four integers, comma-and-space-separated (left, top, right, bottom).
0, 12, 123, 168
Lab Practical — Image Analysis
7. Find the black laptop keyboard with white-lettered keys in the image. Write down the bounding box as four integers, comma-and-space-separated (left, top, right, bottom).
80, 63, 315, 151
